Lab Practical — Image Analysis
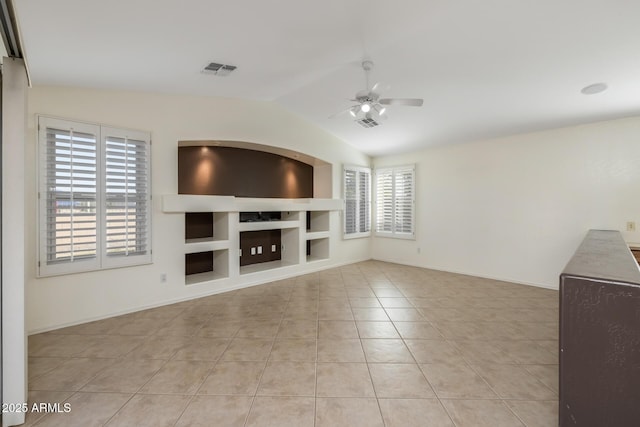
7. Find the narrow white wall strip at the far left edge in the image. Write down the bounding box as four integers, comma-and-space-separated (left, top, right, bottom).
0, 58, 27, 427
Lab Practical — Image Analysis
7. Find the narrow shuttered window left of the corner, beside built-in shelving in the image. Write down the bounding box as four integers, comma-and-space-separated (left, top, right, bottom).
343, 166, 371, 238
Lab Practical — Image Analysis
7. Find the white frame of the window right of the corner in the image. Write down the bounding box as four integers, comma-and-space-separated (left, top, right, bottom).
373, 164, 416, 240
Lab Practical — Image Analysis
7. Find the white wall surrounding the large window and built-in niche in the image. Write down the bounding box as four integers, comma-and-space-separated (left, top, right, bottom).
25, 87, 371, 332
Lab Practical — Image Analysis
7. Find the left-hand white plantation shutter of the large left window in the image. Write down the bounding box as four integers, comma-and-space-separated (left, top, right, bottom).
38, 119, 99, 274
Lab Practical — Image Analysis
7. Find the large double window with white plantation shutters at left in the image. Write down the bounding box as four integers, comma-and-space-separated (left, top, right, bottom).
38, 117, 151, 276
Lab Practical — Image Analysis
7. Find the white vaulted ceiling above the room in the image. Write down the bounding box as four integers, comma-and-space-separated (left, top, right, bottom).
14, 0, 640, 156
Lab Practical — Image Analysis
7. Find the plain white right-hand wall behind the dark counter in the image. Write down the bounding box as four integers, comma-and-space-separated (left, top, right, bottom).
373, 117, 640, 288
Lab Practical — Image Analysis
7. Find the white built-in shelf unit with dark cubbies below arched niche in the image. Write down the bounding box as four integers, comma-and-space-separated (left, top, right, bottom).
162, 195, 342, 287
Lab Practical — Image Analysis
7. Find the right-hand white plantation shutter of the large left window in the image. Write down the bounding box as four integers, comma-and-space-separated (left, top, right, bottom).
103, 128, 151, 264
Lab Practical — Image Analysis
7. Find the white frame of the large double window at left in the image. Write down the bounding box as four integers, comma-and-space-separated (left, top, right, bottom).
36, 115, 153, 277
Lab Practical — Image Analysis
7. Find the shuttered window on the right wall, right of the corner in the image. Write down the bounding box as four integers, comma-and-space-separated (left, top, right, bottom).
374, 166, 415, 239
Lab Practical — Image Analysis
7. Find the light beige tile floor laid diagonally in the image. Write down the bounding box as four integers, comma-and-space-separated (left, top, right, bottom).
27, 261, 558, 427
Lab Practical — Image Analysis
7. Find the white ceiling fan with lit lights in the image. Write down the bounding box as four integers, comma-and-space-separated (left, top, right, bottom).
330, 60, 423, 128
